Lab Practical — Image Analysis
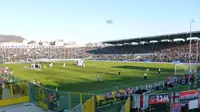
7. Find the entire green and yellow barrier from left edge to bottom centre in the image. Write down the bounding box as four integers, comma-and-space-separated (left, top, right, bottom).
0, 74, 96, 112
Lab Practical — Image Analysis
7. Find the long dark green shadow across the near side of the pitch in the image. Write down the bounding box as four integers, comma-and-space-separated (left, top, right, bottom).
45, 72, 172, 94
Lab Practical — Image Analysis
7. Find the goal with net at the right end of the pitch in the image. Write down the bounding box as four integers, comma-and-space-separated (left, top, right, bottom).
174, 63, 200, 75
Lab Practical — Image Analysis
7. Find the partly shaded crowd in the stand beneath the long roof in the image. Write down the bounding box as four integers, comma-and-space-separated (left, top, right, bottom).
91, 42, 200, 62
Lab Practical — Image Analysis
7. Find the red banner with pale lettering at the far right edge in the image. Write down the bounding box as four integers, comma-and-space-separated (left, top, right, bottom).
180, 90, 199, 103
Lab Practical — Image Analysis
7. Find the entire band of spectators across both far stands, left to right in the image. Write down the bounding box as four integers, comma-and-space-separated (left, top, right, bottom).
0, 42, 200, 62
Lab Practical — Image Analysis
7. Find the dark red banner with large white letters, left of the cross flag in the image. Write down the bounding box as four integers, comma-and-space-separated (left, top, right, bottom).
149, 94, 170, 104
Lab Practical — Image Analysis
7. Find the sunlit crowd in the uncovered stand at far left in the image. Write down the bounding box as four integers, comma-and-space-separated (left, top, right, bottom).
0, 47, 95, 62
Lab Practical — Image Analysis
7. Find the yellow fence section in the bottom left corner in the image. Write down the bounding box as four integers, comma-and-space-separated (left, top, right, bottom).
0, 82, 29, 106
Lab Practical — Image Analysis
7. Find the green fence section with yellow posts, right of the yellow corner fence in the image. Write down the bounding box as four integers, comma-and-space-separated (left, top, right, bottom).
29, 83, 95, 112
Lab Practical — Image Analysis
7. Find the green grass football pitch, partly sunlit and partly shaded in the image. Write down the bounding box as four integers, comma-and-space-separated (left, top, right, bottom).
1, 61, 180, 94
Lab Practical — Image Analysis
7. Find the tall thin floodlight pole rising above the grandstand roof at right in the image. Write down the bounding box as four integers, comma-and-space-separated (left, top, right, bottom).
188, 19, 194, 90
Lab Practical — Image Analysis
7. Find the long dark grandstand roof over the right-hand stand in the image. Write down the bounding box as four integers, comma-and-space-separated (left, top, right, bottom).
103, 31, 200, 44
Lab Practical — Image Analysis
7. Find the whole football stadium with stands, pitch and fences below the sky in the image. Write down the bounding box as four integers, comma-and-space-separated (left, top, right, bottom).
0, 31, 200, 112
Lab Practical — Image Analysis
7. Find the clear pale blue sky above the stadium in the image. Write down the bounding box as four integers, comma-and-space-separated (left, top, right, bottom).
0, 0, 200, 43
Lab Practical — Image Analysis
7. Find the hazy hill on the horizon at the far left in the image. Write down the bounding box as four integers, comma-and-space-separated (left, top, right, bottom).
0, 34, 24, 42
